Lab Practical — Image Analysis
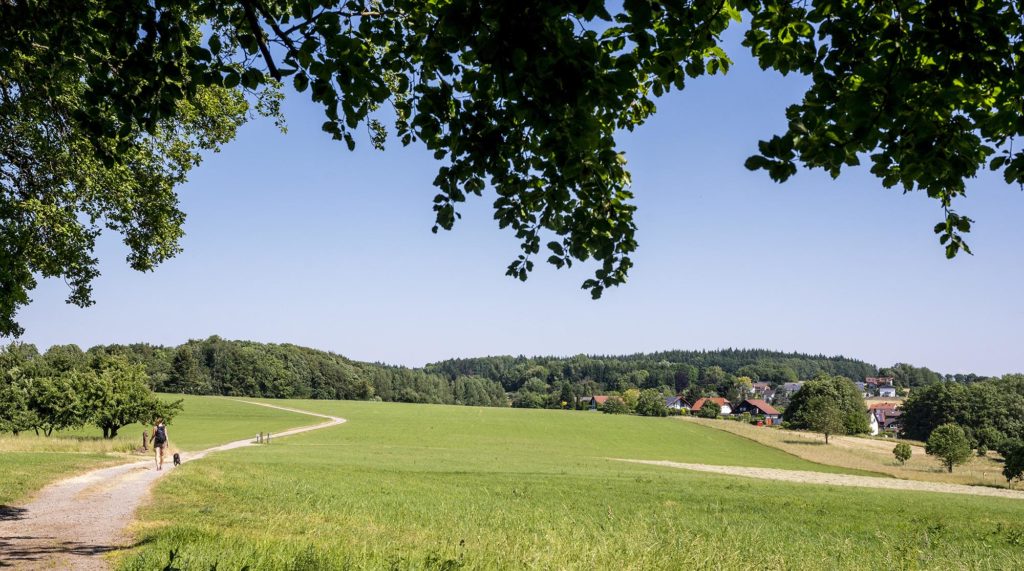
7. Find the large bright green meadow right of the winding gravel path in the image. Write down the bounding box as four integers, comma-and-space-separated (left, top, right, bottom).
119, 401, 1024, 570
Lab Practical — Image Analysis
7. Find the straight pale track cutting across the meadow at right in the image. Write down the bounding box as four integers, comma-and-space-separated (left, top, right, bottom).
609, 458, 1024, 499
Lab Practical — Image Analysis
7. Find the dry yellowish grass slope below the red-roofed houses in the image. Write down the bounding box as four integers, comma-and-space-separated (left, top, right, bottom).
682, 416, 1007, 488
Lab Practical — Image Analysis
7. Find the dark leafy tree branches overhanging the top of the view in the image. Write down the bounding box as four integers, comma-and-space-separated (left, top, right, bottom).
0, 0, 1024, 334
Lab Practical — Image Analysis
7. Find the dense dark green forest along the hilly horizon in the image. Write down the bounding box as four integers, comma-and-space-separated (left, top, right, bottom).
0, 336, 1003, 415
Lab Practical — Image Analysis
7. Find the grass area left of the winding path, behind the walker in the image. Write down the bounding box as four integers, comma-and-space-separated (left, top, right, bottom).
0, 395, 311, 504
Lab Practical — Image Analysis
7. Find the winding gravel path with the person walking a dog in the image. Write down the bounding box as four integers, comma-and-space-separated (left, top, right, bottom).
0, 401, 345, 571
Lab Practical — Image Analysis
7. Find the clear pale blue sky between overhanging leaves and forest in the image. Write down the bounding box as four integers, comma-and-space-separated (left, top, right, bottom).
9, 28, 1024, 375
